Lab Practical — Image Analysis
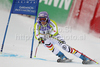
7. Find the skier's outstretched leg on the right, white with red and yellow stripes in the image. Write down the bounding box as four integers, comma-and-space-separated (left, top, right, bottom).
55, 35, 89, 61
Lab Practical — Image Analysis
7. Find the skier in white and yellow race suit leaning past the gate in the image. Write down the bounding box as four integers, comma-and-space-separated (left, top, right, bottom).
34, 11, 91, 64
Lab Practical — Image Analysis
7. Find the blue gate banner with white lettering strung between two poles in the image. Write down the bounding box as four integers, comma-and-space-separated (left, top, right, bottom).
11, 0, 39, 16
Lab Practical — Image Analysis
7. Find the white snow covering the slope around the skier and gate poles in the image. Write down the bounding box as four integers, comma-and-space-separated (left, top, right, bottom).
0, 10, 100, 67
